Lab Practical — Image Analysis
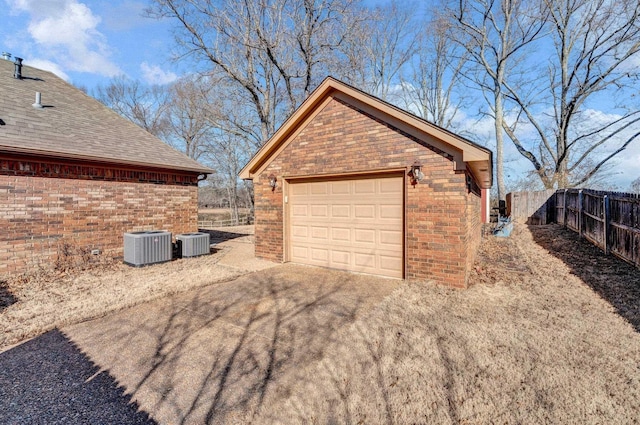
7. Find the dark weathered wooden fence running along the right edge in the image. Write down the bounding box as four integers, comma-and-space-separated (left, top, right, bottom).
554, 189, 640, 267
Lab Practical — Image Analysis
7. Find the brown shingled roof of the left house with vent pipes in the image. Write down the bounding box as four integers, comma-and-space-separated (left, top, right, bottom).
0, 59, 213, 173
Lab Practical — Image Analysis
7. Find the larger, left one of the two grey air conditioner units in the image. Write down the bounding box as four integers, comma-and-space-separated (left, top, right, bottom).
124, 230, 172, 267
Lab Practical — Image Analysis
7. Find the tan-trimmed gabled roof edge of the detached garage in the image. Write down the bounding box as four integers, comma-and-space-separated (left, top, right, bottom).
240, 77, 493, 189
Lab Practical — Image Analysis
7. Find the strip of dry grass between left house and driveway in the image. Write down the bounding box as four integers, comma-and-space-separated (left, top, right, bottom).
0, 226, 260, 351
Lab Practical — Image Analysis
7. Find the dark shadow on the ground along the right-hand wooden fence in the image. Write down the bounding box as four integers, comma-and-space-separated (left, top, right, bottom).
529, 225, 640, 332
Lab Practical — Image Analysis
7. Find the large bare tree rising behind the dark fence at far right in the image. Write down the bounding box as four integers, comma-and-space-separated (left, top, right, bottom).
503, 0, 640, 188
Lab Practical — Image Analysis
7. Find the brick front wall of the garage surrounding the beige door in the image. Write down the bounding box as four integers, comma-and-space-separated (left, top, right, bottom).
254, 99, 480, 287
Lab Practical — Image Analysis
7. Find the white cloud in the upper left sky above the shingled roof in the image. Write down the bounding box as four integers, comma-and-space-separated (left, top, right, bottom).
8, 0, 121, 77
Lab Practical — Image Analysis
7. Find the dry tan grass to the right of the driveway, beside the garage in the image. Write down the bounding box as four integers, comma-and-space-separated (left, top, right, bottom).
254, 226, 640, 424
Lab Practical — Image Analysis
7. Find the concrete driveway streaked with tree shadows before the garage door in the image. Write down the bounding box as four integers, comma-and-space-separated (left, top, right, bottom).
62, 264, 400, 424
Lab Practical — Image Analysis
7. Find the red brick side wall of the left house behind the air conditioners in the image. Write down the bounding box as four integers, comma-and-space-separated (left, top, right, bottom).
0, 160, 198, 274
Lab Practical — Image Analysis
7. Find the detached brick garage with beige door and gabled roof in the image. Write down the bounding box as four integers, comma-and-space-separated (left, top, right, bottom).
240, 78, 492, 287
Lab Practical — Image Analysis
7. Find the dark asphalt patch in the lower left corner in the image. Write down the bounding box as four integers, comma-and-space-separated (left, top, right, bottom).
0, 330, 156, 424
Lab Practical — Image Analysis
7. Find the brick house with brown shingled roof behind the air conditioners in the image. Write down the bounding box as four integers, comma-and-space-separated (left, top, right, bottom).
0, 59, 213, 276
